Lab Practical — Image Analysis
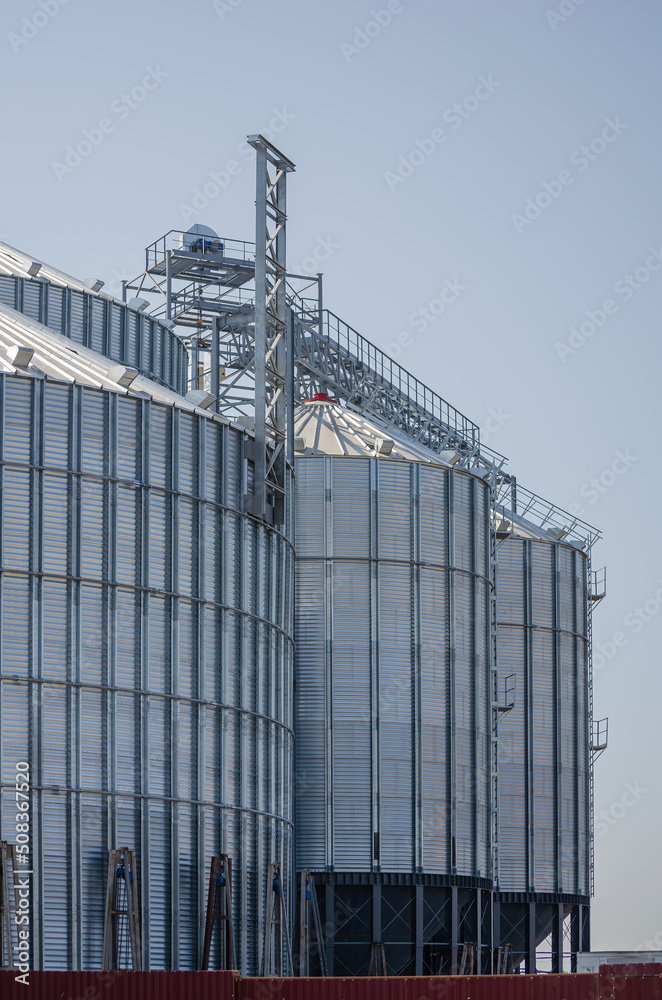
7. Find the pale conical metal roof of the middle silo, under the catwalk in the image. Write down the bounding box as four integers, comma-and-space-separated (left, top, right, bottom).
294, 393, 451, 466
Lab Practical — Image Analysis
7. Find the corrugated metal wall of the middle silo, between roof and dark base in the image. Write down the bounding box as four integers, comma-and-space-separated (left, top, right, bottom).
295, 457, 490, 877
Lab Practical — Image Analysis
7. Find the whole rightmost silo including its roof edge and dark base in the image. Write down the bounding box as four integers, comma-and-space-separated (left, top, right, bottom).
495, 496, 592, 971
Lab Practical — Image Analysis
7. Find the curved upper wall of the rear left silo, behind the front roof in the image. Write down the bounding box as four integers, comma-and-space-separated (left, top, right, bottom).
0, 274, 188, 395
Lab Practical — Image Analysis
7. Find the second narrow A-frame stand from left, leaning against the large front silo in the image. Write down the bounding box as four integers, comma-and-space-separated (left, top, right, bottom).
102, 847, 140, 972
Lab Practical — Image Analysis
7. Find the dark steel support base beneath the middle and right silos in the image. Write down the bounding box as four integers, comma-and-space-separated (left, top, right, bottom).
310, 872, 590, 976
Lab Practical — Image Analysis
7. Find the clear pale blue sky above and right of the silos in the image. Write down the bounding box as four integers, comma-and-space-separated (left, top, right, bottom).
0, 0, 662, 950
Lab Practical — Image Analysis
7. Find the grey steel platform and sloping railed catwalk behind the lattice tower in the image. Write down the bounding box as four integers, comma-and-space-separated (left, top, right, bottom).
124, 230, 488, 458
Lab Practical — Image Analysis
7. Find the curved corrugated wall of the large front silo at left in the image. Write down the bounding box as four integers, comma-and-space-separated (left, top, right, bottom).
0, 376, 293, 973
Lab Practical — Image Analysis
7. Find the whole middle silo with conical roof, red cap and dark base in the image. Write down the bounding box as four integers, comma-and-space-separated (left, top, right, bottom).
295, 401, 492, 974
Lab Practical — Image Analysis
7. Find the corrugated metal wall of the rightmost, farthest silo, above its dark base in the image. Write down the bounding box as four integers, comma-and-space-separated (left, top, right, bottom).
497, 537, 589, 896
